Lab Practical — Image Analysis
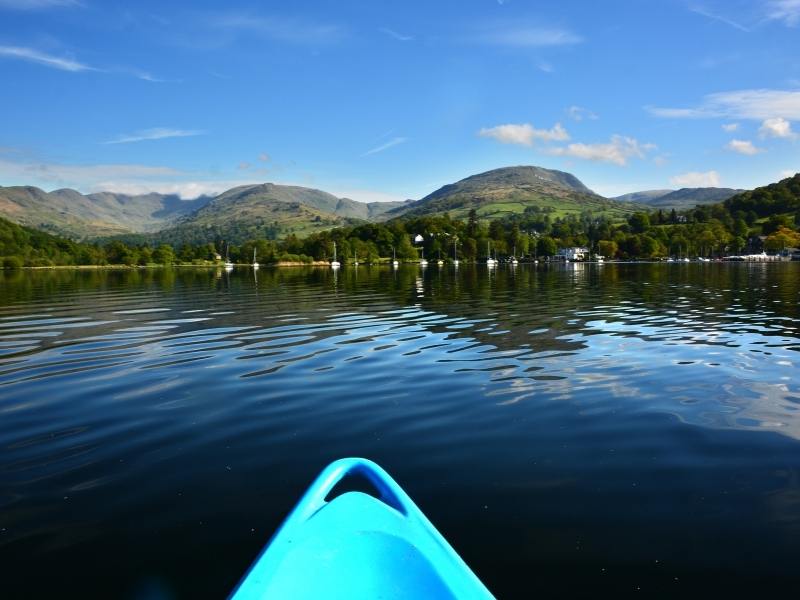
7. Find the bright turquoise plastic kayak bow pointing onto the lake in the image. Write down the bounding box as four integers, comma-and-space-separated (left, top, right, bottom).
231, 458, 492, 600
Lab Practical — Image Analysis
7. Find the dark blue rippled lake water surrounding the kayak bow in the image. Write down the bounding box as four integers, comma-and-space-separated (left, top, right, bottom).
0, 263, 800, 598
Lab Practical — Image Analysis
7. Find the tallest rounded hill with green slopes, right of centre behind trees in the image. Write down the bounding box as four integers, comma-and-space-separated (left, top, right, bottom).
385, 166, 642, 220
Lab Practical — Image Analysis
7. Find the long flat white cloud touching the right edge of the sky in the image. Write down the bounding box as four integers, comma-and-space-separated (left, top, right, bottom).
647, 89, 800, 121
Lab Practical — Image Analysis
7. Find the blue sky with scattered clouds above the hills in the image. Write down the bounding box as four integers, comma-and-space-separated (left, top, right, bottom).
0, 0, 800, 201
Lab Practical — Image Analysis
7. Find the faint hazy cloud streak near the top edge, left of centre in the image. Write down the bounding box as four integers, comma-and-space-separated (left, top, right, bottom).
208, 13, 347, 45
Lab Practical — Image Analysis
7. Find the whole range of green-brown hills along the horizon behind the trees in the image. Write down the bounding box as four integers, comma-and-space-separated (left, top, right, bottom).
0, 166, 756, 243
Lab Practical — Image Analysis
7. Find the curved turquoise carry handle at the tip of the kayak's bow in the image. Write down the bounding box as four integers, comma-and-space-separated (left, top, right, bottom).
293, 458, 414, 521
